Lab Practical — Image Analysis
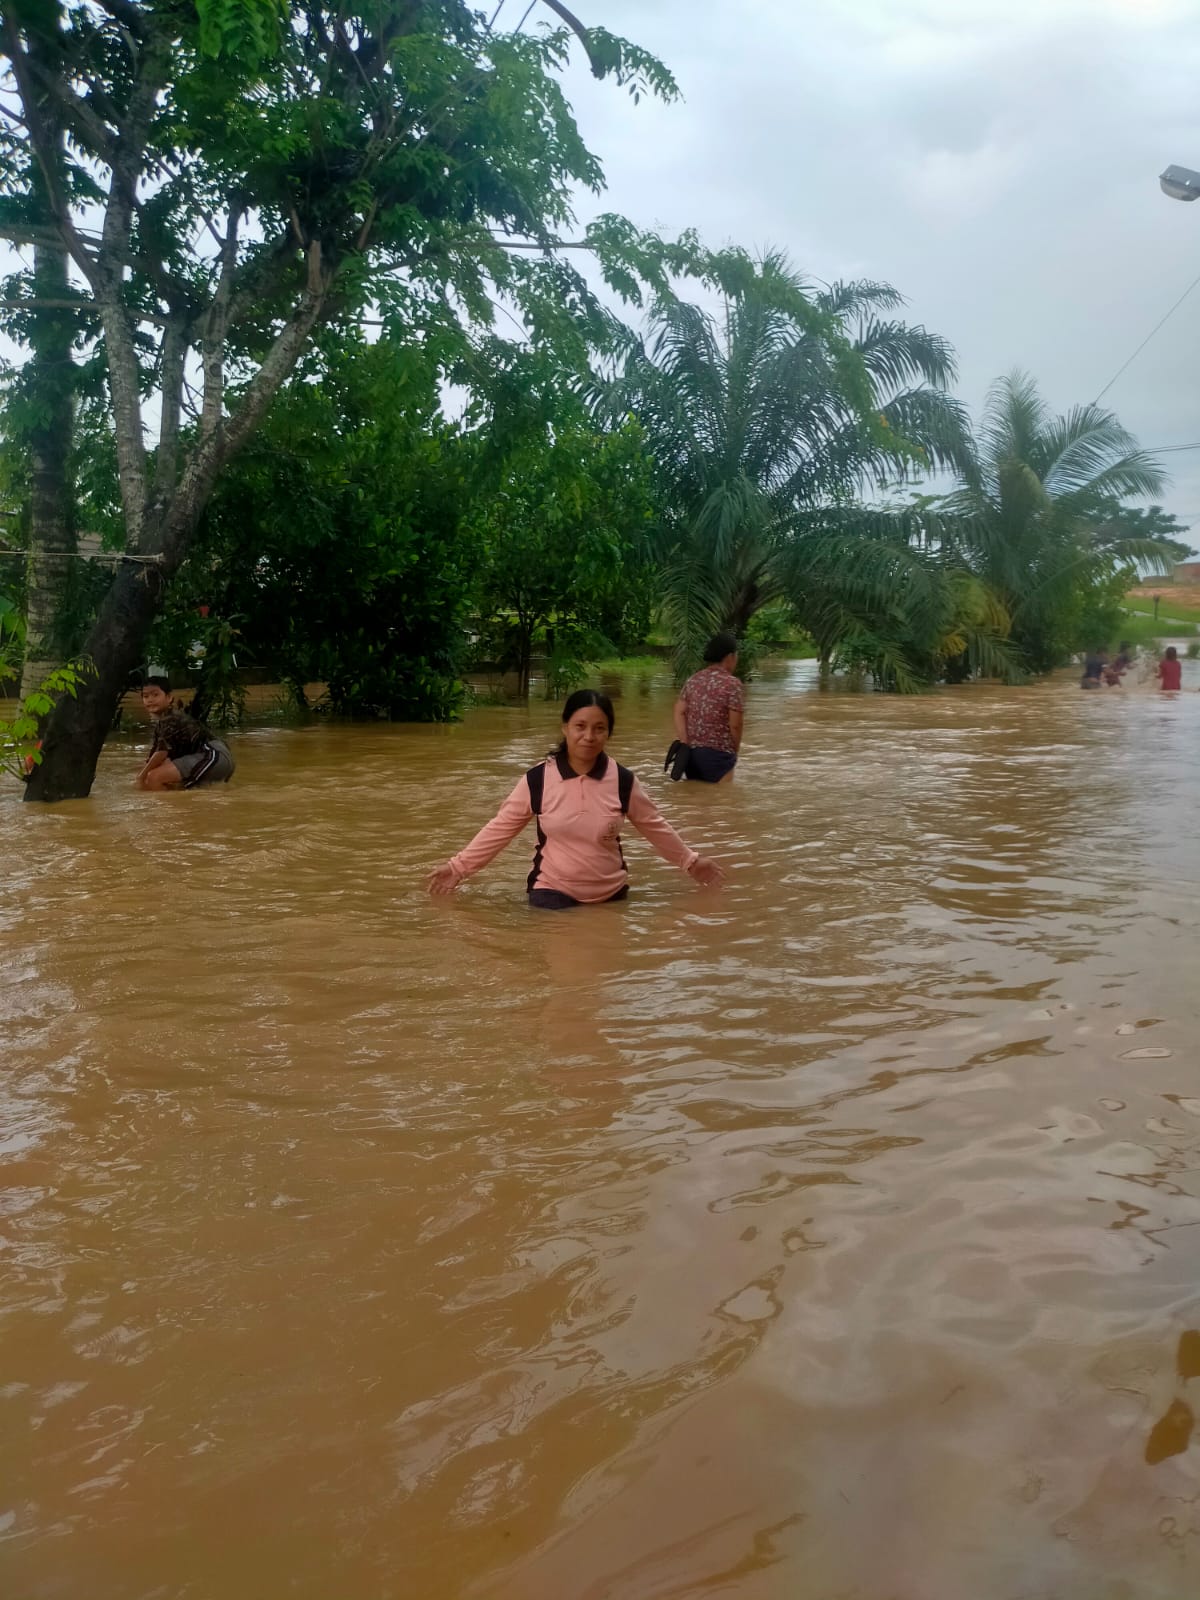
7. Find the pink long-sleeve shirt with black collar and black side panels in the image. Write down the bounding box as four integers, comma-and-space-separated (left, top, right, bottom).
450, 752, 699, 902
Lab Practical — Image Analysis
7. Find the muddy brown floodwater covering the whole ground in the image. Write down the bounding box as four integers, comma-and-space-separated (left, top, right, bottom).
0, 664, 1200, 1600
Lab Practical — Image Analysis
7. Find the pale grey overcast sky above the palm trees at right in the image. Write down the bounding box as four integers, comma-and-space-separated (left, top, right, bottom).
553, 0, 1200, 542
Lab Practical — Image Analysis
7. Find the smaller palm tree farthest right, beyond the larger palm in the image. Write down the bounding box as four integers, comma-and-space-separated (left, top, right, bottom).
941, 373, 1171, 672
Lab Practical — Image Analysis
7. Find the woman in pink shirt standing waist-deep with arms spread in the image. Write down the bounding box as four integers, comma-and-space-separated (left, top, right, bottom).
427, 690, 722, 910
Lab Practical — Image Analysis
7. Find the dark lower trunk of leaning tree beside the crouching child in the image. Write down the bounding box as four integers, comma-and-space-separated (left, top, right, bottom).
26, 562, 165, 800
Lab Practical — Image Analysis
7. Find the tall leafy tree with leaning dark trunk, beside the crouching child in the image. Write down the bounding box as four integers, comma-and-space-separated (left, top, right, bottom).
0, 0, 691, 798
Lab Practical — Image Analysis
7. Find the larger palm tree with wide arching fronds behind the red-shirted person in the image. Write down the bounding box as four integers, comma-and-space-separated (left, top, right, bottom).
608, 251, 970, 672
